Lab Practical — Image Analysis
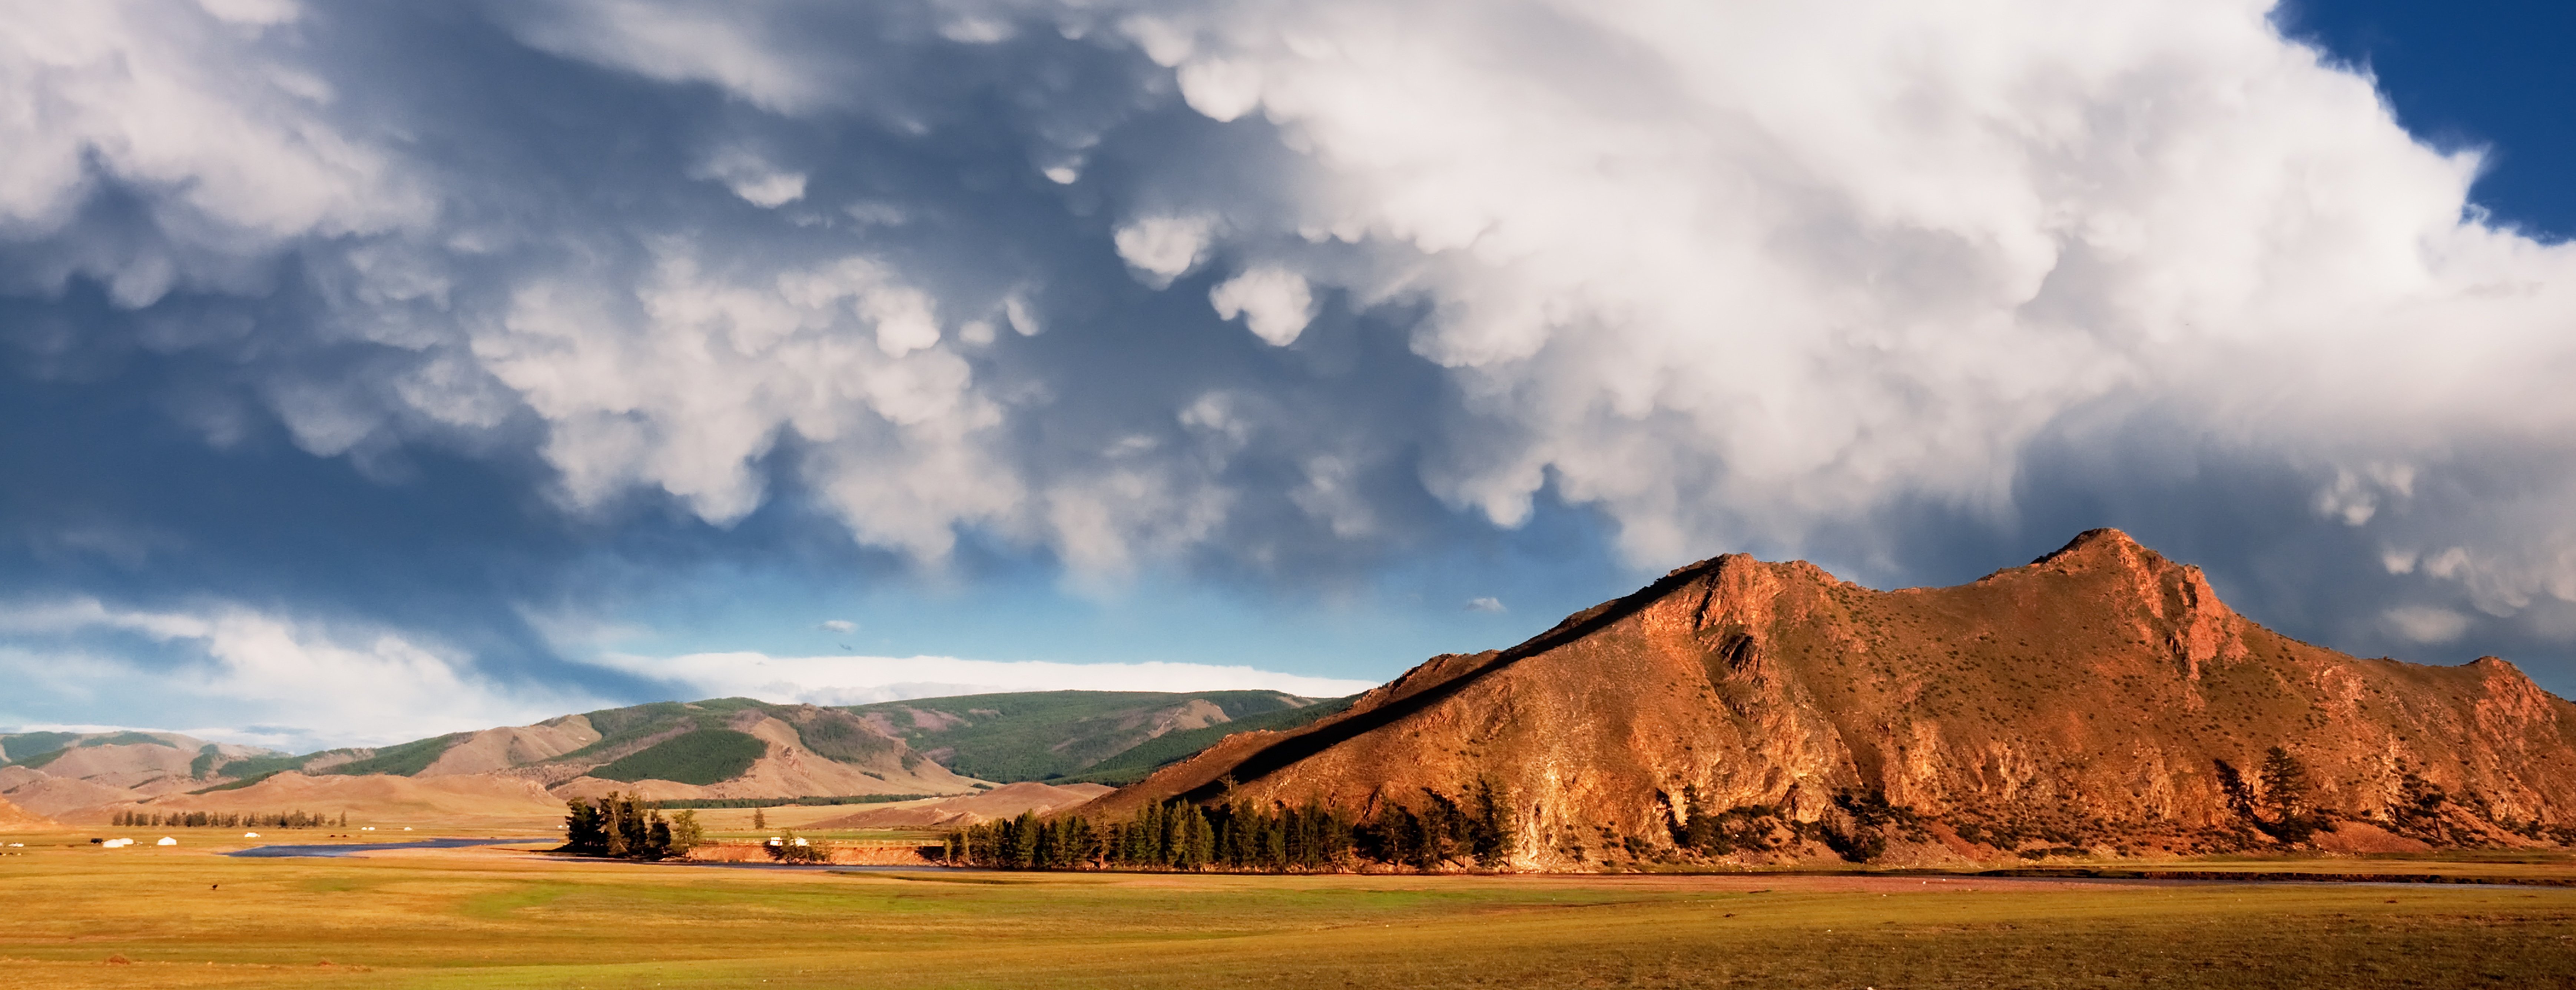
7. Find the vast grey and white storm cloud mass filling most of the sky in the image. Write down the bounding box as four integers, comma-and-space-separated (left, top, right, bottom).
0, 0, 2576, 737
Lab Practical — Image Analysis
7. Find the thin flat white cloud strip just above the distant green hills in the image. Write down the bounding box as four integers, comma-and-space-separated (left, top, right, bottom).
595, 652, 1376, 704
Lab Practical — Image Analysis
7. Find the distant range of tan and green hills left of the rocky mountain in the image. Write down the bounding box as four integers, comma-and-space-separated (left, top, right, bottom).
0, 691, 1380, 820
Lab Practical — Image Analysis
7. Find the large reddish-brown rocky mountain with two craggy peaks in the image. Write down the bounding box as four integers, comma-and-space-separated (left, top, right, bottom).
1095, 531, 2576, 869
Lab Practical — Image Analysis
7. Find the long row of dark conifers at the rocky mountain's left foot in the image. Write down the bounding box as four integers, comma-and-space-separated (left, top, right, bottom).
948, 784, 1512, 871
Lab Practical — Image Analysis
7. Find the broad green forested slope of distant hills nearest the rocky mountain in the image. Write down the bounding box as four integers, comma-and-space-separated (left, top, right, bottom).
845, 691, 1311, 781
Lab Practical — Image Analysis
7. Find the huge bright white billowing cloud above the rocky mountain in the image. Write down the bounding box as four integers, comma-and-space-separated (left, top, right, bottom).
1107, 0, 2576, 619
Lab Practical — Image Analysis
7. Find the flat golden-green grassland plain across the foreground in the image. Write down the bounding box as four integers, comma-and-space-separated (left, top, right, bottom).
0, 833, 2576, 990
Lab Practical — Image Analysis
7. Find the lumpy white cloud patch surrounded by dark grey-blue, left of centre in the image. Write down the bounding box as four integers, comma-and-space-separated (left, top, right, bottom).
474, 242, 1015, 547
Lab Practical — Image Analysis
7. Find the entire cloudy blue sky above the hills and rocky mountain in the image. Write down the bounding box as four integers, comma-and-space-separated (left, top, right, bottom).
0, 0, 2576, 750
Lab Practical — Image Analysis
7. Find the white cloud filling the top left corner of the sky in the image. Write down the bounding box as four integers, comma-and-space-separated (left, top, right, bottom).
0, 0, 430, 307
